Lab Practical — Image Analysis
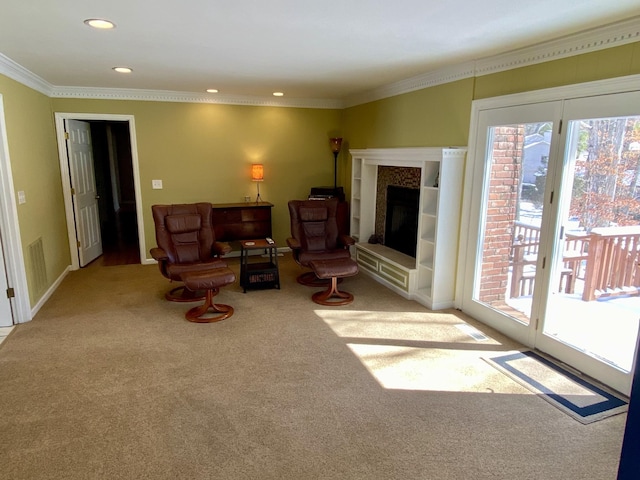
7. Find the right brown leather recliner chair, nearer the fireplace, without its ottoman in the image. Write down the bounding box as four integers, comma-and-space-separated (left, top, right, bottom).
287, 198, 355, 286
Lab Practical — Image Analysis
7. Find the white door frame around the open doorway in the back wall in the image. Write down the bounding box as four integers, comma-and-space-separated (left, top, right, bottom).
55, 112, 146, 270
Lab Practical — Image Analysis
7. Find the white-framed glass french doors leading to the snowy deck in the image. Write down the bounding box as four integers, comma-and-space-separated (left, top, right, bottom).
462, 88, 640, 394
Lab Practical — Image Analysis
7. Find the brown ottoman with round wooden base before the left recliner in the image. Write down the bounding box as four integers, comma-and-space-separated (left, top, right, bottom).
182, 267, 236, 323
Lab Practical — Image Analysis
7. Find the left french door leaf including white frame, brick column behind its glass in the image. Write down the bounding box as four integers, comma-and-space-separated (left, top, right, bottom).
462, 102, 561, 345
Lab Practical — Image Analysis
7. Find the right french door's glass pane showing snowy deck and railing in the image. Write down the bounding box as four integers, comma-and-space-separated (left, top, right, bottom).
538, 116, 640, 390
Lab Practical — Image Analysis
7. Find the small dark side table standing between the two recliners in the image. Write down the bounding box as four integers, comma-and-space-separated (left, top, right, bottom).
240, 238, 280, 293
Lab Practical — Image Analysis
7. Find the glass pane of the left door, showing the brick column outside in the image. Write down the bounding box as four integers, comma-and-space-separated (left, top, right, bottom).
473, 122, 553, 325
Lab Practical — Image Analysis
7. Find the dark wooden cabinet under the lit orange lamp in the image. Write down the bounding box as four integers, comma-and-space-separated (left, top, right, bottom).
212, 202, 273, 242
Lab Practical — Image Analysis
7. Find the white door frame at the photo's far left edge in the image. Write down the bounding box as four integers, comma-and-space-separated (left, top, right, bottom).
0, 94, 32, 323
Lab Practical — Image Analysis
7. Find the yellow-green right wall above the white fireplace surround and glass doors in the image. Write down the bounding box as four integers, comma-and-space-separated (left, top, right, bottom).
342, 42, 640, 202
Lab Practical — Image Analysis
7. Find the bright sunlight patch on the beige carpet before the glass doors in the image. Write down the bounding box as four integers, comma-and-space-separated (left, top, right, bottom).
315, 310, 521, 393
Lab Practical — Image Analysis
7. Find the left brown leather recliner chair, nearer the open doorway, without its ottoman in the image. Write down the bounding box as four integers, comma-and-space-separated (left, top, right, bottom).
150, 202, 231, 302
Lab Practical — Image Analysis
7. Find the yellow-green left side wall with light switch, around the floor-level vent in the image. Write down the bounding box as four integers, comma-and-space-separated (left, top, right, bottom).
0, 75, 71, 306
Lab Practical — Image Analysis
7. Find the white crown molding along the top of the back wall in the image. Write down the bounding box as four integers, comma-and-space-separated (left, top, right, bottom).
50, 87, 344, 109
